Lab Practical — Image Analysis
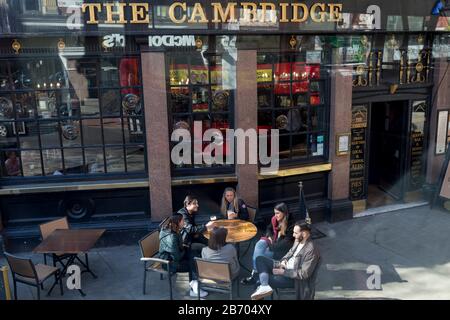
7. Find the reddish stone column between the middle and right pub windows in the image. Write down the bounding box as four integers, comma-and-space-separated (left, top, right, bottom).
234, 50, 258, 206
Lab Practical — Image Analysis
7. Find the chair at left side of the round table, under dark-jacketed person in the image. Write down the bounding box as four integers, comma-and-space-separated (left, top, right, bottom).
139, 230, 173, 300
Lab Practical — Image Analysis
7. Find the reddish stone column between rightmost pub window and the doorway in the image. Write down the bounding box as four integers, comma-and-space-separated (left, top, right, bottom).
328, 66, 353, 221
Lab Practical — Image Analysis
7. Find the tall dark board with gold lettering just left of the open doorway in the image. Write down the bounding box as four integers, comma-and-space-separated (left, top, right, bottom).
350, 106, 367, 200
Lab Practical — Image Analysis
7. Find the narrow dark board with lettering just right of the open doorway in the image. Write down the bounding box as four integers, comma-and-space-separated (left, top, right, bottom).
410, 101, 426, 190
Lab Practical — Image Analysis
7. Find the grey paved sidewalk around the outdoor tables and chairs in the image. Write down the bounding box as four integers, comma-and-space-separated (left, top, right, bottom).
0, 207, 450, 300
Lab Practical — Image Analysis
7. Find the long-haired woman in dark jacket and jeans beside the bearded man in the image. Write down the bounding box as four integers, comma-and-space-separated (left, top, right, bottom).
241, 203, 295, 284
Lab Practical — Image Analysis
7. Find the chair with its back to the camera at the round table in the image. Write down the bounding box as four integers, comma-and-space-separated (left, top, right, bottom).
194, 257, 239, 300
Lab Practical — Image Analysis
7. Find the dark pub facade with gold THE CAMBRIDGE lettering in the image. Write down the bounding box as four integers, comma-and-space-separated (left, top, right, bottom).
0, 0, 450, 237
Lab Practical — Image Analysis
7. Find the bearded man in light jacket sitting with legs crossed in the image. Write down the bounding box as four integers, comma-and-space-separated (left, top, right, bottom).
251, 221, 320, 300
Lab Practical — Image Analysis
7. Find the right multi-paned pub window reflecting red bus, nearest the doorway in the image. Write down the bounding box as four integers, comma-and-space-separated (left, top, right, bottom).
257, 51, 328, 164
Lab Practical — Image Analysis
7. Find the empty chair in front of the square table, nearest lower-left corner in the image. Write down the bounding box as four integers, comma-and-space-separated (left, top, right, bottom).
5, 252, 64, 300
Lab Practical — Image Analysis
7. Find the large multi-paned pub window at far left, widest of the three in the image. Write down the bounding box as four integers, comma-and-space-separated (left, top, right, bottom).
0, 54, 145, 179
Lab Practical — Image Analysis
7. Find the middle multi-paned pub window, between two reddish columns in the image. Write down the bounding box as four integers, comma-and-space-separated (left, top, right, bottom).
168, 51, 235, 176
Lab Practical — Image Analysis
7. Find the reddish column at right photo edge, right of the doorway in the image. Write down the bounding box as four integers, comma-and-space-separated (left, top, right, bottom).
426, 59, 450, 184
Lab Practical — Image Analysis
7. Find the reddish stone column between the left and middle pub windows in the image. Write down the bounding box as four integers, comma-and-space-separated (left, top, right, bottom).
141, 52, 172, 221
